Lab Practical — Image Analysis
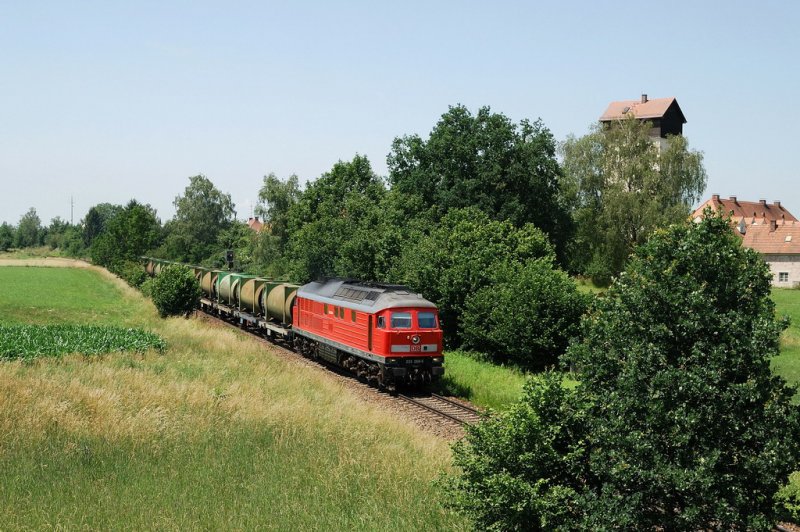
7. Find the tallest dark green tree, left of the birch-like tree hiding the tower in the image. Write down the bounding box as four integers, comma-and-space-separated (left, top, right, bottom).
388, 105, 572, 257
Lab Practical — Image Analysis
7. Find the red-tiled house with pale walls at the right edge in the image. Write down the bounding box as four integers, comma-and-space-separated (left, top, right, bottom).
692, 194, 800, 288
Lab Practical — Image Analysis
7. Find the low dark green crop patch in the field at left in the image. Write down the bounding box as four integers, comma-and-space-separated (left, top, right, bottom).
0, 324, 166, 359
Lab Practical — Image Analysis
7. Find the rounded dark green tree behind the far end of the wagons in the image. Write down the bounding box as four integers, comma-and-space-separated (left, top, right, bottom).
90, 200, 161, 271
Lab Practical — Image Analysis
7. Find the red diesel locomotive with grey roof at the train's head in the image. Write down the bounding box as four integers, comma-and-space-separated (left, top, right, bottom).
292, 279, 444, 388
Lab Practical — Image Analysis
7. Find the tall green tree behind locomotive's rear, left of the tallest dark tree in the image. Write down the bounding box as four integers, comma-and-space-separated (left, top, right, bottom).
287, 155, 386, 281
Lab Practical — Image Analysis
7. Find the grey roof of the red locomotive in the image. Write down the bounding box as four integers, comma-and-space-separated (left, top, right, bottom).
297, 279, 436, 314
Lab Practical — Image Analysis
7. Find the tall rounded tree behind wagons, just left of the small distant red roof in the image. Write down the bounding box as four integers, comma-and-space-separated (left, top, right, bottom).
165, 175, 236, 263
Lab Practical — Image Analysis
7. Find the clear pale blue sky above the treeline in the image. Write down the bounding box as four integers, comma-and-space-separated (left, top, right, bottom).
0, 0, 800, 223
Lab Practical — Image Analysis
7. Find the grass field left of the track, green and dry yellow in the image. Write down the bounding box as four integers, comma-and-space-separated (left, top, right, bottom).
0, 267, 466, 530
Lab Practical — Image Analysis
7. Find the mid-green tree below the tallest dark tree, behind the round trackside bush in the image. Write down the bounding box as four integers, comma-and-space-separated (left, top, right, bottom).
397, 208, 555, 343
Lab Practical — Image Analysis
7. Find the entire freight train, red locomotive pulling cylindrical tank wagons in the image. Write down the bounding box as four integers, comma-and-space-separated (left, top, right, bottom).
144, 257, 444, 391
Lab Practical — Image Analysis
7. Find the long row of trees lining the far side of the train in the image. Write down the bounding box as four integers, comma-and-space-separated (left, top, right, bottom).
4, 106, 705, 366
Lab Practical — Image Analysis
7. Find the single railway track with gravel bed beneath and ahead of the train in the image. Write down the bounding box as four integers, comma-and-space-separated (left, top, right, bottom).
197, 310, 482, 427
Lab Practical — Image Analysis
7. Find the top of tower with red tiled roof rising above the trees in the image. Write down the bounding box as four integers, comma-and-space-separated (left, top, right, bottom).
600, 94, 686, 138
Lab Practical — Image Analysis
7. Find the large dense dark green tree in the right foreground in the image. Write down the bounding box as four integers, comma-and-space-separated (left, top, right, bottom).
452, 211, 800, 530
